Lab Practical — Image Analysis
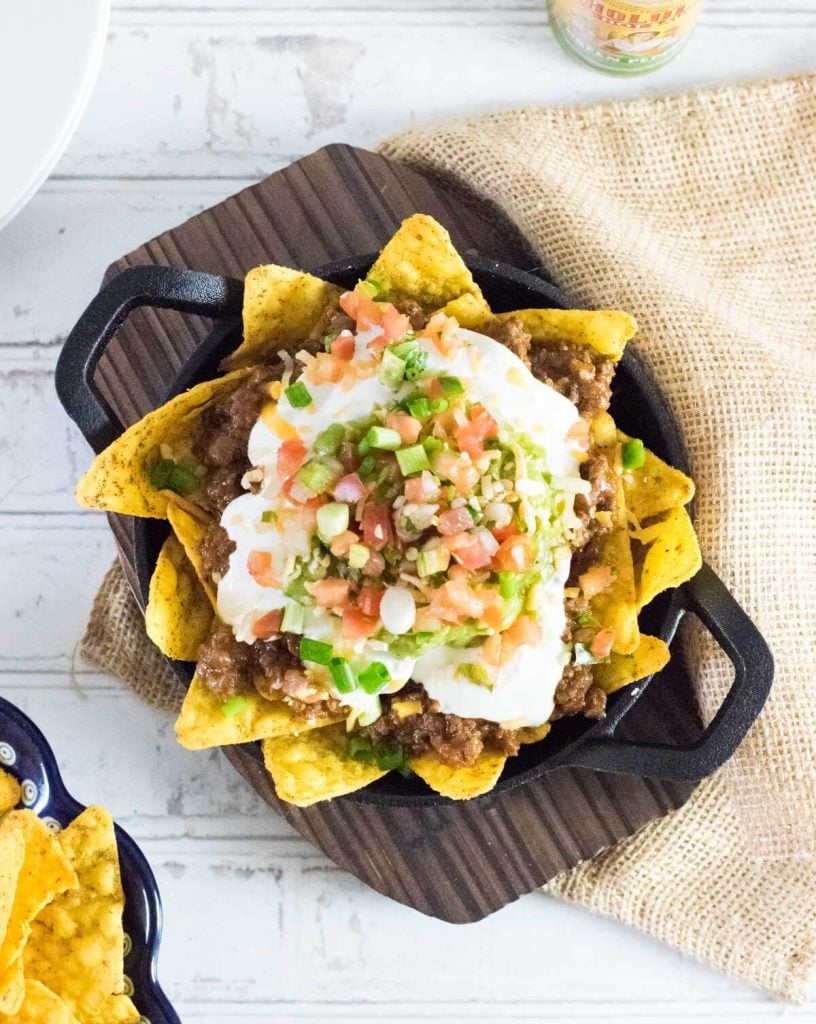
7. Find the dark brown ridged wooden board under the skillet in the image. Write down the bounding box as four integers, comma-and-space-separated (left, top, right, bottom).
96, 145, 699, 923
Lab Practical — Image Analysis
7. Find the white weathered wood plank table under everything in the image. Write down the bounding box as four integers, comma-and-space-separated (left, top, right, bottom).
0, 0, 816, 1024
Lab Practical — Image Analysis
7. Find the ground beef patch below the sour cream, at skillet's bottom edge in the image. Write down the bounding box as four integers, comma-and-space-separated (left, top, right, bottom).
362, 683, 519, 767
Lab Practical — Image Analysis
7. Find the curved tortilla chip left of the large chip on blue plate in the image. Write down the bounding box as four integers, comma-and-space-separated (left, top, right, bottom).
0, 811, 77, 1014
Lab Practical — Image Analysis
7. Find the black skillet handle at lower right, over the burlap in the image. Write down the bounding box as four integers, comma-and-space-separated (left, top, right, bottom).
559, 565, 774, 782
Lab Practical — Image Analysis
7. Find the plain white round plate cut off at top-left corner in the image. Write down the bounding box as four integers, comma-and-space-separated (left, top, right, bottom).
0, 0, 111, 227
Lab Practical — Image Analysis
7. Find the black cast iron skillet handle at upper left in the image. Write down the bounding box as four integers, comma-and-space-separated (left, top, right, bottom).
55, 266, 244, 452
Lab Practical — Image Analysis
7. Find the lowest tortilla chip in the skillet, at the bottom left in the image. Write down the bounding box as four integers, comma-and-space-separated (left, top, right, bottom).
263, 723, 386, 807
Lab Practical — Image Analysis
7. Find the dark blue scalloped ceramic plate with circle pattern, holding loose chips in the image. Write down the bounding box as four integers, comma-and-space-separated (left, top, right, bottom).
0, 697, 181, 1024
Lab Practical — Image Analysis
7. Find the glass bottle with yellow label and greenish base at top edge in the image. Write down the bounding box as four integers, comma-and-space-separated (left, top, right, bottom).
547, 0, 702, 75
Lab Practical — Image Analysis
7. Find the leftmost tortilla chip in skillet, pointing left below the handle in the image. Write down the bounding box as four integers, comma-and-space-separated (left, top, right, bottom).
75, 370, 249, 519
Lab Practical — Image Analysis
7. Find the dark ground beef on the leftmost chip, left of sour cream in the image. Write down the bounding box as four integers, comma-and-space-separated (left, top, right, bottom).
192, 365, 280, 517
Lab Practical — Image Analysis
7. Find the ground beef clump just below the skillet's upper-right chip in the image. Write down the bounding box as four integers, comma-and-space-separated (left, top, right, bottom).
531, 342, 614, 420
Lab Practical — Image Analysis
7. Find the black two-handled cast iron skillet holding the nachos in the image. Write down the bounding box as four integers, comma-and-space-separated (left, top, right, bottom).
56, 255, 773, 805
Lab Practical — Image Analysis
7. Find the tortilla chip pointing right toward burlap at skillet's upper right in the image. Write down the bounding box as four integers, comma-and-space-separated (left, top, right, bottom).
497, 309, 638, 360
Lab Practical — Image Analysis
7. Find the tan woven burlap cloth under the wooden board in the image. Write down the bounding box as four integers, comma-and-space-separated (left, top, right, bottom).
82, 77, 816, 1001
